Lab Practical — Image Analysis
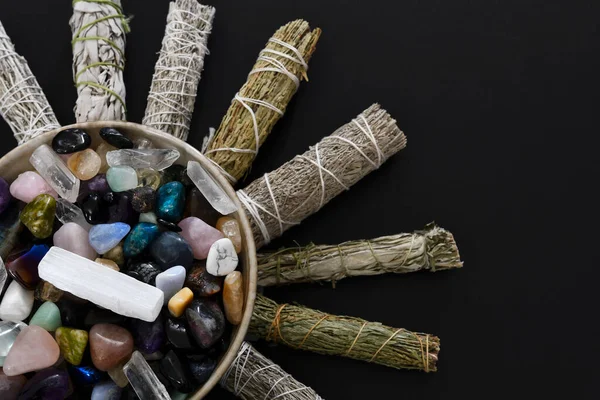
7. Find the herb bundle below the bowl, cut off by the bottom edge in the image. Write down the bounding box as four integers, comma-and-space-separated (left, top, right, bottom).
221, 342, 322, 400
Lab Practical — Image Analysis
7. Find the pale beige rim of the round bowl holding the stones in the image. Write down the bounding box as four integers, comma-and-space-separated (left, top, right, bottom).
0, 121, 258, 400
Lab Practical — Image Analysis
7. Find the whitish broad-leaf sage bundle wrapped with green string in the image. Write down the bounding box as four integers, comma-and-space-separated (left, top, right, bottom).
70, 0, 129, 122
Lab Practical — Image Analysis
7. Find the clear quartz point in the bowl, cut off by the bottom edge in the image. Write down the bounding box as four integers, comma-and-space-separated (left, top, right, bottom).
123, 350, 171, 400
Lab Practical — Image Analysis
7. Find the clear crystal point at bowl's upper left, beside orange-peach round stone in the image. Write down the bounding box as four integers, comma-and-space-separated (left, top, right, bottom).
29, 144, 81, 203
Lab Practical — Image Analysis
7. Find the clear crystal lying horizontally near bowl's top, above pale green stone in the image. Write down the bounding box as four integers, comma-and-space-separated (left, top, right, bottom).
106, 149, 179, 171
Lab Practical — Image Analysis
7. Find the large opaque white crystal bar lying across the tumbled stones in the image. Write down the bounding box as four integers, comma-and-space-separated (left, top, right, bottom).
38, 246, 164, 322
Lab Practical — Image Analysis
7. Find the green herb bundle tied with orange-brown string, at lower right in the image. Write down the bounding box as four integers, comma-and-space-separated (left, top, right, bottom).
248, 295, 440, 372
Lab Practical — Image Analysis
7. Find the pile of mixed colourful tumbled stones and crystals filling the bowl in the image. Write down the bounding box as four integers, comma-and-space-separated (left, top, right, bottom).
0, 128, 244, 400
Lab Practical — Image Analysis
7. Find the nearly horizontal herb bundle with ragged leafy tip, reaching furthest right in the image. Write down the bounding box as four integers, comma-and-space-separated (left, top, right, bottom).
257, 224, 463, 286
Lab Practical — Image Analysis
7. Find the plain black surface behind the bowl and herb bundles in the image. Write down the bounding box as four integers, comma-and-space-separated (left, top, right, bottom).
0, 0, 600, 399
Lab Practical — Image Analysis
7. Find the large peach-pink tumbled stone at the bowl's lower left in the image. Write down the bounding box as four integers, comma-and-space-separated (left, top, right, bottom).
3, 325, 60, 376
